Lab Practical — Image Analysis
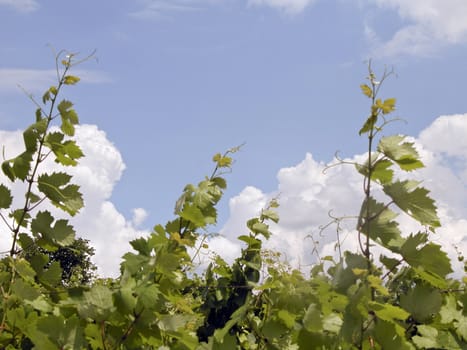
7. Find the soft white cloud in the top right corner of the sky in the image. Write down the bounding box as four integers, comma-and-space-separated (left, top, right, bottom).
366, 0, 467, 56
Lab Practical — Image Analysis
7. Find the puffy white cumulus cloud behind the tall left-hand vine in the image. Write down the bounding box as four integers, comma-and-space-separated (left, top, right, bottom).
0, 125, 147, 276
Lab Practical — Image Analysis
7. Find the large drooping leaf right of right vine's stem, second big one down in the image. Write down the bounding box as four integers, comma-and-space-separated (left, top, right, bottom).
383, 180, 440, 227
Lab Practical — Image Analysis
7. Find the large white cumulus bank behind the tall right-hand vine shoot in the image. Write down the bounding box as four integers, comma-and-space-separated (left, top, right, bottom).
218, 114, 467, 276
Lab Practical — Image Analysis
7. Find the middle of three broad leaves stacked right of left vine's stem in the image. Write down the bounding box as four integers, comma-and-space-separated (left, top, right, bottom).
38, 173, 83, 216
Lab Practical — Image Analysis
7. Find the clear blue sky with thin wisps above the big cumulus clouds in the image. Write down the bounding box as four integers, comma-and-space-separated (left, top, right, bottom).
0, 0, 467, 274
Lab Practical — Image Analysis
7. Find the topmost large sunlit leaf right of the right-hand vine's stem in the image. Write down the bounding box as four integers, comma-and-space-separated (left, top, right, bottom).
378, 135, 424, 171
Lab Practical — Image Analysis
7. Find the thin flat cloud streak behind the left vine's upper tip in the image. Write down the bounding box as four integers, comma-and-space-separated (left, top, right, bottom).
0, 68, 111, 93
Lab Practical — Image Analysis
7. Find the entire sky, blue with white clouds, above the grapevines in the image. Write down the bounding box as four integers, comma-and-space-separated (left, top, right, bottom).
0, 0, 467, 275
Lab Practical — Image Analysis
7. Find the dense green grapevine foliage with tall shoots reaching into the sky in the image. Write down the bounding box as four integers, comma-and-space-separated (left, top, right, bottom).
0, 55, 467, 349
